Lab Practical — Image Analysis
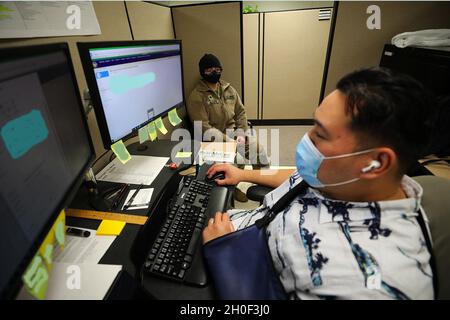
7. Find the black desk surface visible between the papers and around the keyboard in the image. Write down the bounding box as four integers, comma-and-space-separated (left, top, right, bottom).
67, 140, 218, 299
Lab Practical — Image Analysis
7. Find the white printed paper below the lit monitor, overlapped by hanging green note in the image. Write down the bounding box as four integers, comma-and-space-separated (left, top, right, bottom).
96, 156, 169, 185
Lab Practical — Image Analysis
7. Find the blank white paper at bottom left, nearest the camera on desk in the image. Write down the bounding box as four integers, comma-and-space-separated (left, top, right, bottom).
45, 263, 122, 300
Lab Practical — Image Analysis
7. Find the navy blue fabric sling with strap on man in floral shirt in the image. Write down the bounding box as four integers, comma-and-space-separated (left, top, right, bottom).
203, 181, 308, 300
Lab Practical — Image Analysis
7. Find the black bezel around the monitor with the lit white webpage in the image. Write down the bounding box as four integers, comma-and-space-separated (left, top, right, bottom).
77, 39, 186, 150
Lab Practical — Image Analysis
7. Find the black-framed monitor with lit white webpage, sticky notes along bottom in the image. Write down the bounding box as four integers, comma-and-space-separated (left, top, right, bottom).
78, 40, 184, 149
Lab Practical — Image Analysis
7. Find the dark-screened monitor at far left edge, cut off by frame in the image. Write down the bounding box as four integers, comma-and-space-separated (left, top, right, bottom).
0, 44, 94, 299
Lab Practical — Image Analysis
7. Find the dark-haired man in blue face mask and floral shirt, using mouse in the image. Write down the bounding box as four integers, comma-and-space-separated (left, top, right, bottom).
203, 68, 433, 299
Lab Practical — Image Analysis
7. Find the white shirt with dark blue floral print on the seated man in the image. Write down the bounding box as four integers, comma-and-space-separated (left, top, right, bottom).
230, 172, 433, 299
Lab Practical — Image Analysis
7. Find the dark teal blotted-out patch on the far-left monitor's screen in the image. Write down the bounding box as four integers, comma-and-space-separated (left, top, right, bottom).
0, 109, 48, 159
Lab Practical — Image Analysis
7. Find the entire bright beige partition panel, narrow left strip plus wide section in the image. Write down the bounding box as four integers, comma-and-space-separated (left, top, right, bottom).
243, 8, 332, 120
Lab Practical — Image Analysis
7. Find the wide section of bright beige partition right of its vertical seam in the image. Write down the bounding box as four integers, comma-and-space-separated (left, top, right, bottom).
261, 9, 331, 119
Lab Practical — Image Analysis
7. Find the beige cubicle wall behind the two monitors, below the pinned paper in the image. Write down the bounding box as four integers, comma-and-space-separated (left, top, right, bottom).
0, 1, 173, 168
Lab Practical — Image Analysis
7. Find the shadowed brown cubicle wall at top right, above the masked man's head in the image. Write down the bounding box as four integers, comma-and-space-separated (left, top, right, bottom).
325, 1, 450, 94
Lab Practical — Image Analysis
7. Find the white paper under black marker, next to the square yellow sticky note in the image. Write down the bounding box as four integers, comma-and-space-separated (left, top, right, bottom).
53, 228, 116, 263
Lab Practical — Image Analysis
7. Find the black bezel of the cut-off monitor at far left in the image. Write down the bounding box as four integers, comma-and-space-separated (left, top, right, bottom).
0, 43, 95, 299
